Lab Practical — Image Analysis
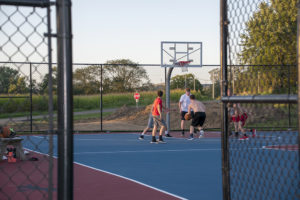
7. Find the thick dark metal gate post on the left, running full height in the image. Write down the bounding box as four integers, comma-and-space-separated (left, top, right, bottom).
56, 0, 73, 200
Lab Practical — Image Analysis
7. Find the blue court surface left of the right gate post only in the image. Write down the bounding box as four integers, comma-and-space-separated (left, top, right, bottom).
23, 133, 222, 200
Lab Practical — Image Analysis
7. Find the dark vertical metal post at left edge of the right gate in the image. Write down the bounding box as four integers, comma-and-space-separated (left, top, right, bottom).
220, 0, 230, 200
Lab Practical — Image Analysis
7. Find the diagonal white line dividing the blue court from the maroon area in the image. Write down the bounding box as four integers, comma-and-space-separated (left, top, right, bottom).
24, 148, 188, 200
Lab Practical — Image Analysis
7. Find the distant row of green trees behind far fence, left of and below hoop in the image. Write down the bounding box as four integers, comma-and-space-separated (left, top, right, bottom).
0, 59, 202, 95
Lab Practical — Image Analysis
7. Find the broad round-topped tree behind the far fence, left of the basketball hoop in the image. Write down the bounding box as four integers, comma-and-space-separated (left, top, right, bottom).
104, 59, 150, 92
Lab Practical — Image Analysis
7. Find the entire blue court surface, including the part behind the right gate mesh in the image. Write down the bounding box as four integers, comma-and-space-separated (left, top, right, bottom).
23, 132, 299, 200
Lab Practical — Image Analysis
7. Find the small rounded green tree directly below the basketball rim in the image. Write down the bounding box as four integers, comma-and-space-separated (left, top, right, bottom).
170, 74, 203, 91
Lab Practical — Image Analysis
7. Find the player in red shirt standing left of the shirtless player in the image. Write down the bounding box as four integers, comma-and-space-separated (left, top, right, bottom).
151, 90, 167, 143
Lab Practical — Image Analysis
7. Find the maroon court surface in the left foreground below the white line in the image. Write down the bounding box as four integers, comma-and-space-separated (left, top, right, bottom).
0, 153, 180, 200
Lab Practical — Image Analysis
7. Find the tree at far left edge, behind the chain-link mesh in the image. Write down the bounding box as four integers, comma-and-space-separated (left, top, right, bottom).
0, 66, 20, 94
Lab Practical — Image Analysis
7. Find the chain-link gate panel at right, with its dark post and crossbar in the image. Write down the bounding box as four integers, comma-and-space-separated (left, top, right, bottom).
220, 0, 300, 200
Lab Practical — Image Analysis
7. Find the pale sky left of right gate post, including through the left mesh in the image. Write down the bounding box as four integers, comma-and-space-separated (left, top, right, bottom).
0, 0, 220, 83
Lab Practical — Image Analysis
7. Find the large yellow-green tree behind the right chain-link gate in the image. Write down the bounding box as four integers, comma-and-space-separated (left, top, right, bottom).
235, 0, 297, 93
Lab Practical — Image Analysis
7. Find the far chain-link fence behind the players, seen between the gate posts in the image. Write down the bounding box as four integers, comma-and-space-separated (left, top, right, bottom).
70, 63, 220, 132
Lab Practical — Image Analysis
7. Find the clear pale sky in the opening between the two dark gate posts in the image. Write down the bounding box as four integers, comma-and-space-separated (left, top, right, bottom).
72, 0, 220, 83
